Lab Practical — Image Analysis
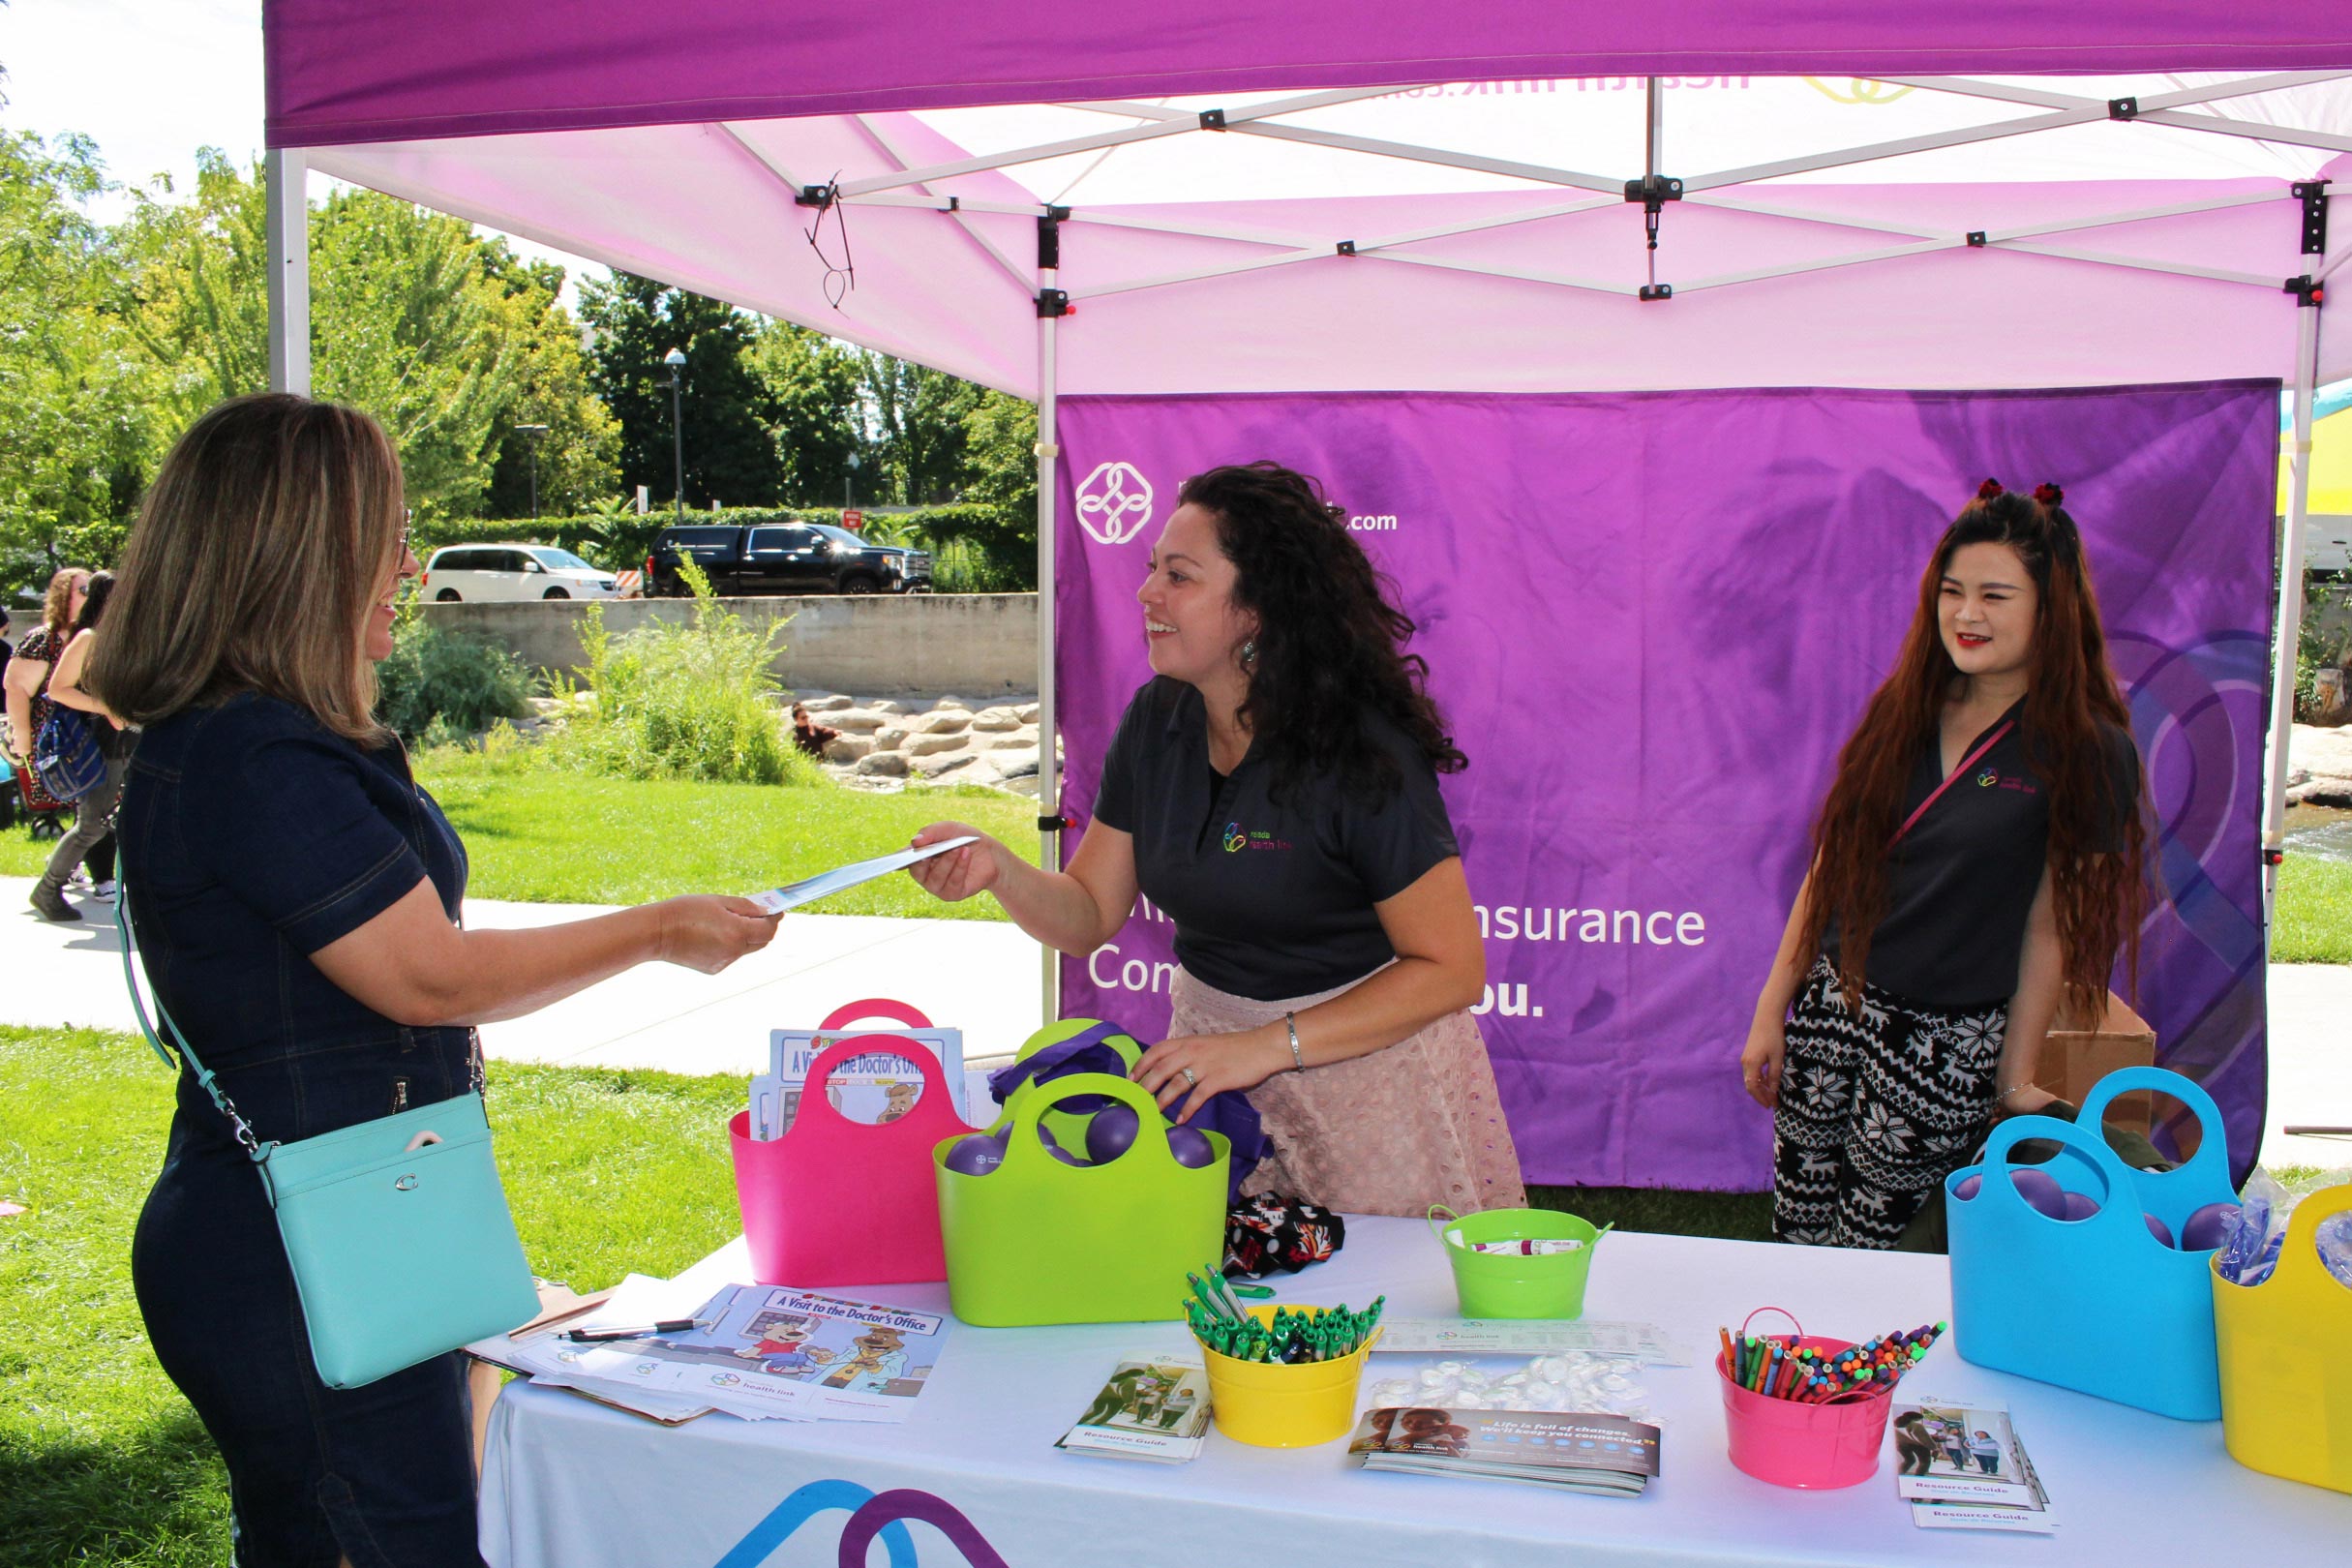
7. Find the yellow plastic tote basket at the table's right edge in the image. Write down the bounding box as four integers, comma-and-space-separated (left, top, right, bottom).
2214, 1185, 2352, 1493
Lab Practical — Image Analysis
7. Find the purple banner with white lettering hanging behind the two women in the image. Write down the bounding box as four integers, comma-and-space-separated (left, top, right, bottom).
1054, 383, 2279, 1191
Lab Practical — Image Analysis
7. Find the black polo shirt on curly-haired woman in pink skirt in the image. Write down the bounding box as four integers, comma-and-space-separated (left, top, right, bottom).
1094, 677, 1461, 1002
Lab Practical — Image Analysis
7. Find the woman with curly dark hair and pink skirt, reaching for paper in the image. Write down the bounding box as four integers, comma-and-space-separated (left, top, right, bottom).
913, 463, 1526, 1216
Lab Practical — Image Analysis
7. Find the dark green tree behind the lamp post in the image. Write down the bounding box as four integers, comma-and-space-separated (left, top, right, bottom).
581, 273, 783, 510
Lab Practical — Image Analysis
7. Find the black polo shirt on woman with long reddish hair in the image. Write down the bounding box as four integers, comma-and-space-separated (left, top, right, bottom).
1823, 698, 2140, 1009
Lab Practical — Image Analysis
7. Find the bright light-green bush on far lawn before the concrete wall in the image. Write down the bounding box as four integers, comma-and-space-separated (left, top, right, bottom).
541, 561, 826, 785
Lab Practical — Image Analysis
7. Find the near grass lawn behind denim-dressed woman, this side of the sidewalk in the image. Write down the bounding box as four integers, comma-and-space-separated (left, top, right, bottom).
0, 1027, 743, 1568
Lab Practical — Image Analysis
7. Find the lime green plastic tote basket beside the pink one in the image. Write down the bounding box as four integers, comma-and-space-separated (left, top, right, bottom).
931, 1072, 1232, 1328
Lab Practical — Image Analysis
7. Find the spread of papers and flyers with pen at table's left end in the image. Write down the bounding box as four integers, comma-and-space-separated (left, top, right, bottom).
466, 1274, 946, 1422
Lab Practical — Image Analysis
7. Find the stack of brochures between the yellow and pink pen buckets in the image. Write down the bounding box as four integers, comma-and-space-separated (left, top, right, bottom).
1347, 1405, 1658, 1497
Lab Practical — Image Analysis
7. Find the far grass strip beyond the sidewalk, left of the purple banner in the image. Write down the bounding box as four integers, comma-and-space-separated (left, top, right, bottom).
0, 752, 1041, 920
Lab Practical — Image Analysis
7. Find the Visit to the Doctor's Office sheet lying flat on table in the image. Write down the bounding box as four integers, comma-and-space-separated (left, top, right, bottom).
558, 1286, 946, 1422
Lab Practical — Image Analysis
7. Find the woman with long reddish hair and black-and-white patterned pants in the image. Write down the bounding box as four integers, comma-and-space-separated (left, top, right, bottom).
1740, 479, 2148, 1249
